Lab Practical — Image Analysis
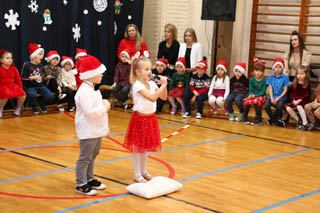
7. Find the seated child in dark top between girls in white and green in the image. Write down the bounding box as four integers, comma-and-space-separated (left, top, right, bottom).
226, 62, 249, 121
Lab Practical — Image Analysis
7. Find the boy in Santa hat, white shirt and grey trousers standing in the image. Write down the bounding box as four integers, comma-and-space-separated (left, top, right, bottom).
75, 55, 110, 195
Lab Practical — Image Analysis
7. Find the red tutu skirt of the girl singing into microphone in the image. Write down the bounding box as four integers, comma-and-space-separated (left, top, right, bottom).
123, 112, 161, 153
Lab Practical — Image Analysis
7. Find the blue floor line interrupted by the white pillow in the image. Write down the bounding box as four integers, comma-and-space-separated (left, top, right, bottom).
53, 148, 317, 212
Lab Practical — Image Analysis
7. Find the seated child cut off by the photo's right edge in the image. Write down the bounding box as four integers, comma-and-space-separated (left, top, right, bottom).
304, 85, 320, 131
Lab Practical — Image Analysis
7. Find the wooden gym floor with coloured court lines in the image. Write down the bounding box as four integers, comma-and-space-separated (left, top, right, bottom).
0, 105, 320, 213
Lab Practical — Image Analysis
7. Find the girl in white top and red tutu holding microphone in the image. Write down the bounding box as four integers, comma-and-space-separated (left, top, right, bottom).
123, 58, 167, 183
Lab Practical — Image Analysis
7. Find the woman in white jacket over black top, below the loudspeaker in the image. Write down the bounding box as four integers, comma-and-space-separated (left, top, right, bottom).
178, 28, 203, 72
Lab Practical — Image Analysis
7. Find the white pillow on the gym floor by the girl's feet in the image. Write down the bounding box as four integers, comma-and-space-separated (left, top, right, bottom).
126, 176, 182, 199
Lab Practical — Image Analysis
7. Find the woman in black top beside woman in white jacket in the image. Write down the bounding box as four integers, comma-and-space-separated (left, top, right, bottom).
158, 24, 180, 70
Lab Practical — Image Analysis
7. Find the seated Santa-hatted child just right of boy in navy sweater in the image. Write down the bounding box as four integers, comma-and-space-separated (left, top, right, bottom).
41, 50, 67, 112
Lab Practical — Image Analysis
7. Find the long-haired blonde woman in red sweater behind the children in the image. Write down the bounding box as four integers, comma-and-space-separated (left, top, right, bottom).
117, 24, 150, 58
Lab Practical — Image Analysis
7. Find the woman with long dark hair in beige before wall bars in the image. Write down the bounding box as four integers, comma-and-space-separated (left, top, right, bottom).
283, 31, 311, 82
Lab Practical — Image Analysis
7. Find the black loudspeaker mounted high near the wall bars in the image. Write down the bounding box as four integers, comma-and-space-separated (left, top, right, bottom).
201, 0, 237, 21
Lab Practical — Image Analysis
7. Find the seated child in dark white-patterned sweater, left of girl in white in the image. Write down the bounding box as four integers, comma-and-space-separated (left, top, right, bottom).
182, 60, 210, 119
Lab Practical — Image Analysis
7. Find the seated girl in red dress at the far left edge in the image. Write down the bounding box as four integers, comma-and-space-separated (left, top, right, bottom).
0, 49, 26, 117
